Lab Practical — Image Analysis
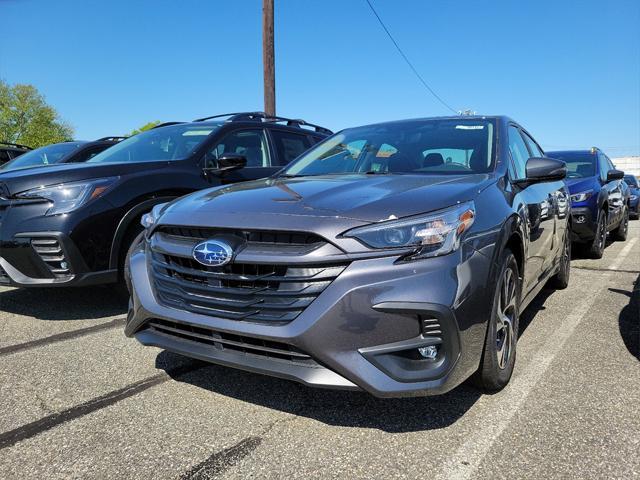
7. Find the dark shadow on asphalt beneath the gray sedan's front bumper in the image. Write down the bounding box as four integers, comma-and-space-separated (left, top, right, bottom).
156, 351, 481, 433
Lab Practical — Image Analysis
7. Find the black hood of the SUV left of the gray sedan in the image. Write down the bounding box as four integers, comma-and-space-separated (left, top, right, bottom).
0, 162, 169, 195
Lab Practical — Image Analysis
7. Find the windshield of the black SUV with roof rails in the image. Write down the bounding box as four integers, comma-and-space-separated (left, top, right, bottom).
87, 123, 222, 163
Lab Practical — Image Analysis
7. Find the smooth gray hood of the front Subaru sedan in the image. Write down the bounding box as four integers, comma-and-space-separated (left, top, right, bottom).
161, 174, 494, 228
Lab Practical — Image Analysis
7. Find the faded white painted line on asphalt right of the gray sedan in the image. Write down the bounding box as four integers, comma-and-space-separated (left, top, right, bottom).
436, 238, 638, 480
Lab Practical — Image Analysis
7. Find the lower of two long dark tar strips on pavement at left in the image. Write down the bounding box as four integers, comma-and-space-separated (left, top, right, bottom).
0, 364, 206, 450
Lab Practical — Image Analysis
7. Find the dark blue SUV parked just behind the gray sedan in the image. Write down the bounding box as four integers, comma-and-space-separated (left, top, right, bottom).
547, 147, 630, 258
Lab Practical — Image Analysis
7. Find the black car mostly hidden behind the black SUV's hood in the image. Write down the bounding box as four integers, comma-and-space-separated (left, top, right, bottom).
0, 137, 127, 173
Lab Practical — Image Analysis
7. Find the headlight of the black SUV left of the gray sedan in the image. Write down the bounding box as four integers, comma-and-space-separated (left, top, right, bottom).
16, 177, 119, 215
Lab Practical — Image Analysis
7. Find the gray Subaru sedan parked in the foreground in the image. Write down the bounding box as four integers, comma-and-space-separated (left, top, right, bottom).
126, 116, 571, 397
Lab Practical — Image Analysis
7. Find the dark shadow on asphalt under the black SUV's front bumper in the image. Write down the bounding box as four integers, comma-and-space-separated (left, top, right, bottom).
0, 285, 127, 321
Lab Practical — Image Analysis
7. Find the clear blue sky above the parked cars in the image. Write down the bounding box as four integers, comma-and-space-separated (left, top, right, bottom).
0, 0, 640, 157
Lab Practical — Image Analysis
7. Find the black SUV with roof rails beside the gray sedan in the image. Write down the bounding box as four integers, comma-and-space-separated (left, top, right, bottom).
0, 112, 331, 287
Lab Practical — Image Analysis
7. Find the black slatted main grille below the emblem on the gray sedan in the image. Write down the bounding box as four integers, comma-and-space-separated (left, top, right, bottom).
151, 251, 346, 323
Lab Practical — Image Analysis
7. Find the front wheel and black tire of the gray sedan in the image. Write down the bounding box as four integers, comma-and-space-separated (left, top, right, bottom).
472, 249, 522, 392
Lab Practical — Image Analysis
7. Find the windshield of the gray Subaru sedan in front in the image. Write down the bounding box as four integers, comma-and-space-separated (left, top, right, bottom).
282, 118, 495, 176
